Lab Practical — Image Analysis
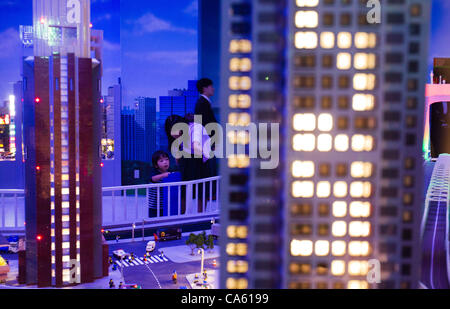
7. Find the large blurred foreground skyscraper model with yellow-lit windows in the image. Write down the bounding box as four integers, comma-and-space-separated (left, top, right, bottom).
220, 0, 430, 288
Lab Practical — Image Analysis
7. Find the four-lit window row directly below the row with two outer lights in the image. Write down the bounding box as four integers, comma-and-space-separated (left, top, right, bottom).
292, 181, 372, 198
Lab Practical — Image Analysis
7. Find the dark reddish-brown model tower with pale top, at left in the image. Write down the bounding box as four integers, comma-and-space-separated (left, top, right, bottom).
23, 0, 103, 287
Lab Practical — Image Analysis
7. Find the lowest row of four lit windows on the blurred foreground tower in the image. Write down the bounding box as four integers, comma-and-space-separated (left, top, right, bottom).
291, 239, 371, 256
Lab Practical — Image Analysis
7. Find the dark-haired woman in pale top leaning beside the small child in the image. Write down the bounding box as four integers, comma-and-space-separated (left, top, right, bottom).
165, 114, 212, 212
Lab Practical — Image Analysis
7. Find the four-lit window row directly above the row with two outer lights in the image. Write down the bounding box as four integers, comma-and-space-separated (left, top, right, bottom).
292, 134, 374, 152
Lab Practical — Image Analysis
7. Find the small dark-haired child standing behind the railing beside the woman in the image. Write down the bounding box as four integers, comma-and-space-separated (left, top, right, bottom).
148, 150, 171, 217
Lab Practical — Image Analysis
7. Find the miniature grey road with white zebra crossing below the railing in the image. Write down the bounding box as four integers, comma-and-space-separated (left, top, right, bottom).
109, 237, 214, 289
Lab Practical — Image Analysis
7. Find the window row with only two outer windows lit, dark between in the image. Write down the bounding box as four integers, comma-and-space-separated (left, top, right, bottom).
291, 160, 373, 178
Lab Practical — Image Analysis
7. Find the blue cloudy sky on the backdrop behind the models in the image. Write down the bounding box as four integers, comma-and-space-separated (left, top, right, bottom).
0, 0, 450, 105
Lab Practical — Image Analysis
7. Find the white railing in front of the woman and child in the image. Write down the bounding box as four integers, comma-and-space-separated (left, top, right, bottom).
0, 176, 220, 232
